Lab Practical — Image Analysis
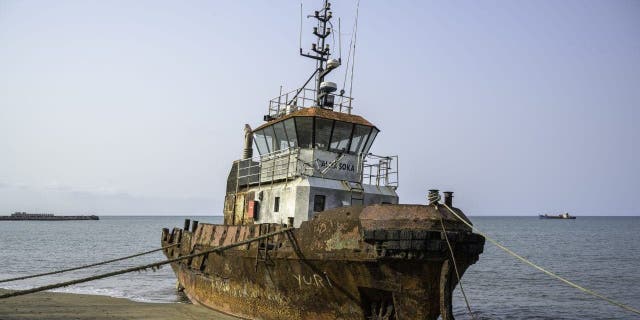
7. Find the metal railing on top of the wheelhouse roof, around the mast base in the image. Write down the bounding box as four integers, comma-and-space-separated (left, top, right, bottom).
269, 88, 353, 119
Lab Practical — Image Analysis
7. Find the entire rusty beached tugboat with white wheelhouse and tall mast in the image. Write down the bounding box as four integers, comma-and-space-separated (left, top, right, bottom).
162, 1, 484, 320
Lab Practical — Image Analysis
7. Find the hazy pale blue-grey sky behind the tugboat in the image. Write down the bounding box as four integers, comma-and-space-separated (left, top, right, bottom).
0, 0, 640, 216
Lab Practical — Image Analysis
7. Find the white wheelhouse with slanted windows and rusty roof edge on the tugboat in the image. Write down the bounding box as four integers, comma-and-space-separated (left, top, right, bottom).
224, 102, 398, 227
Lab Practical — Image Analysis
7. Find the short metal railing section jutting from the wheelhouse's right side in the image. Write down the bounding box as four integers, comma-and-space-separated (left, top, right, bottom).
362, 153, 400, 189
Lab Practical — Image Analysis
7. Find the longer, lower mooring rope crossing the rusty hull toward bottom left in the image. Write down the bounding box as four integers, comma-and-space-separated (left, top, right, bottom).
0, 228, 293, 299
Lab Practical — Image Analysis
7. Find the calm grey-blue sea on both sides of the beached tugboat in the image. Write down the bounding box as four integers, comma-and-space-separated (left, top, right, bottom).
0, 217, 640, 320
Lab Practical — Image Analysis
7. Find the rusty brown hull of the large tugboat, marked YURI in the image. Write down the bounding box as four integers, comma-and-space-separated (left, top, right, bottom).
162, 205, 484, 320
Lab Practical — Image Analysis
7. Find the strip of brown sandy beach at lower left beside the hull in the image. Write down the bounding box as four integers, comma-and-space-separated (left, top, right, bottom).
0, 289, 238, 320
